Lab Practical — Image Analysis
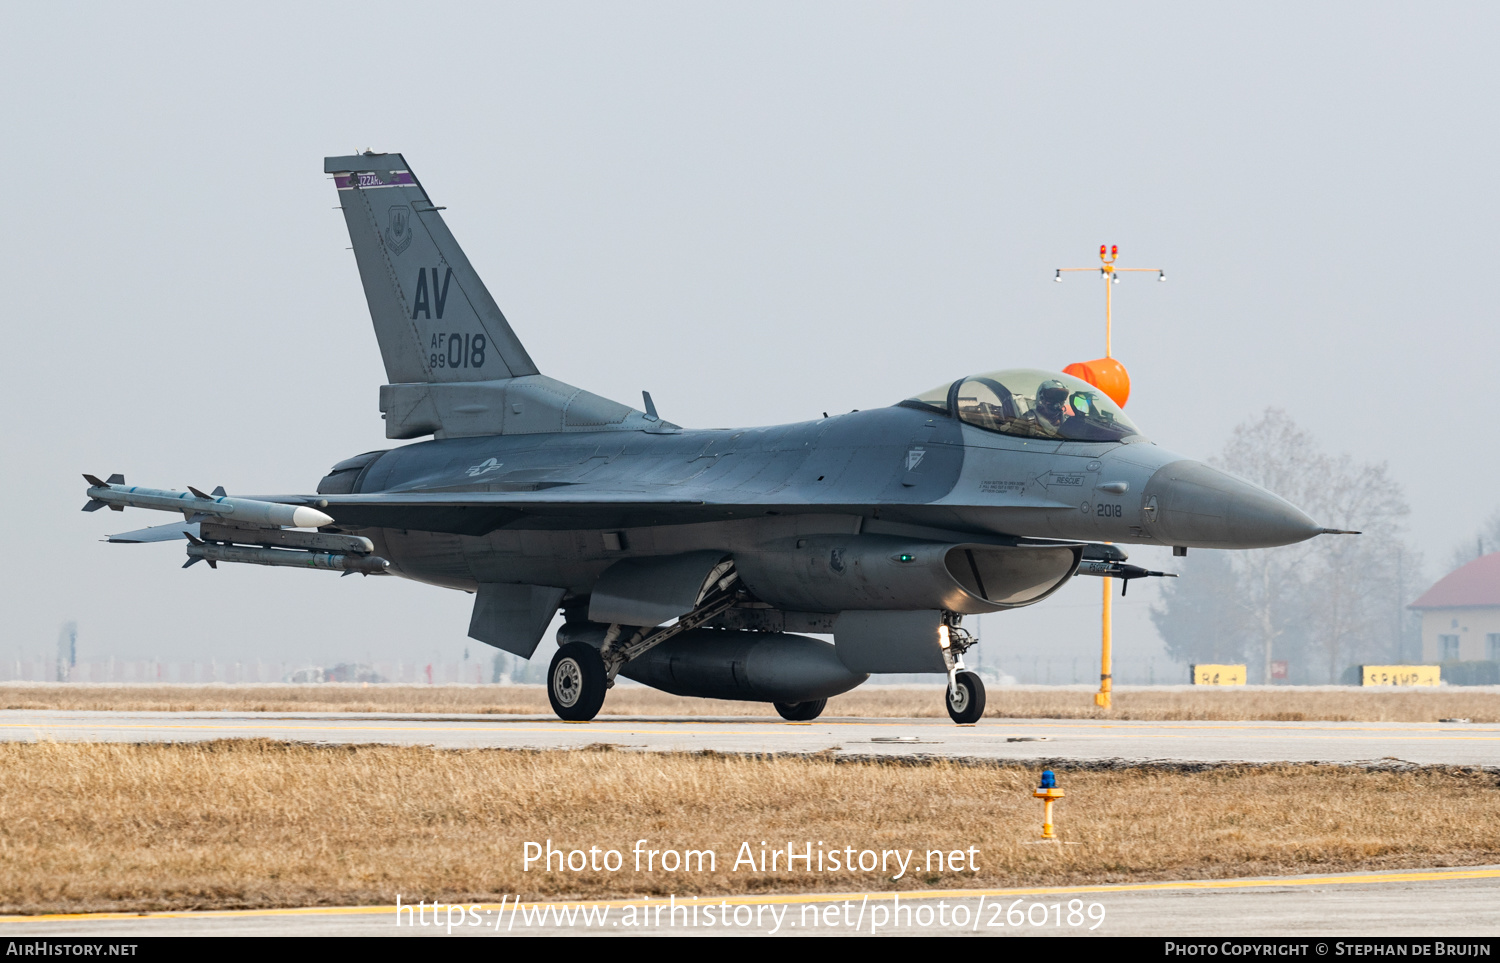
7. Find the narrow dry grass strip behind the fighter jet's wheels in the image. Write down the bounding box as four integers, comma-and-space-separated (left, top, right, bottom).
0, 683, 1500, 723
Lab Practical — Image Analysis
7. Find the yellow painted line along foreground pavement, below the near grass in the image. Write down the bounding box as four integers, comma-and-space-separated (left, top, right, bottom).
0, 867, 1500, 924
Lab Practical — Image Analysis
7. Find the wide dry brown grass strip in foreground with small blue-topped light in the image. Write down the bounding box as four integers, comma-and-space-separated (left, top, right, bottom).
0, 741, 1500, 914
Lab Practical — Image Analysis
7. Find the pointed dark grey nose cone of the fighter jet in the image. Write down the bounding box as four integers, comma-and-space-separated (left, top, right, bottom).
1142, 459, 1323, 549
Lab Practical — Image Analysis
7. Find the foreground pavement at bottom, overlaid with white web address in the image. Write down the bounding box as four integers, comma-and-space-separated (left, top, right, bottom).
0, 866, 1500, 930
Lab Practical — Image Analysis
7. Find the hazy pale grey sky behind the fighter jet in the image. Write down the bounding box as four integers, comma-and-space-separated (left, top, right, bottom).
0, 2, 1500, 672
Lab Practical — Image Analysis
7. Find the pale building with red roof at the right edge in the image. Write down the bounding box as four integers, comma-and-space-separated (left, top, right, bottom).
1409, 552, 1500, 665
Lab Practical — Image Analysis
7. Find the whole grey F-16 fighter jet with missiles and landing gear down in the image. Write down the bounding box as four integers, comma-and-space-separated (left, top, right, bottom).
86, 153, 1328, 723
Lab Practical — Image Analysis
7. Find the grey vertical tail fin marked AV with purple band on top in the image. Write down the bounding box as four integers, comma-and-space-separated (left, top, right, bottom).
323, 153, 537, 384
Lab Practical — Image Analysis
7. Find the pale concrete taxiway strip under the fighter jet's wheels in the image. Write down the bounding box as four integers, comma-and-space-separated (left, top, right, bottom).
0, 710, 1500, 765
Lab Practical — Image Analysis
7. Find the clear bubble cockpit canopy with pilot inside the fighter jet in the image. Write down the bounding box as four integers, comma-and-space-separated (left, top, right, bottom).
902, 368, 1140, 441
